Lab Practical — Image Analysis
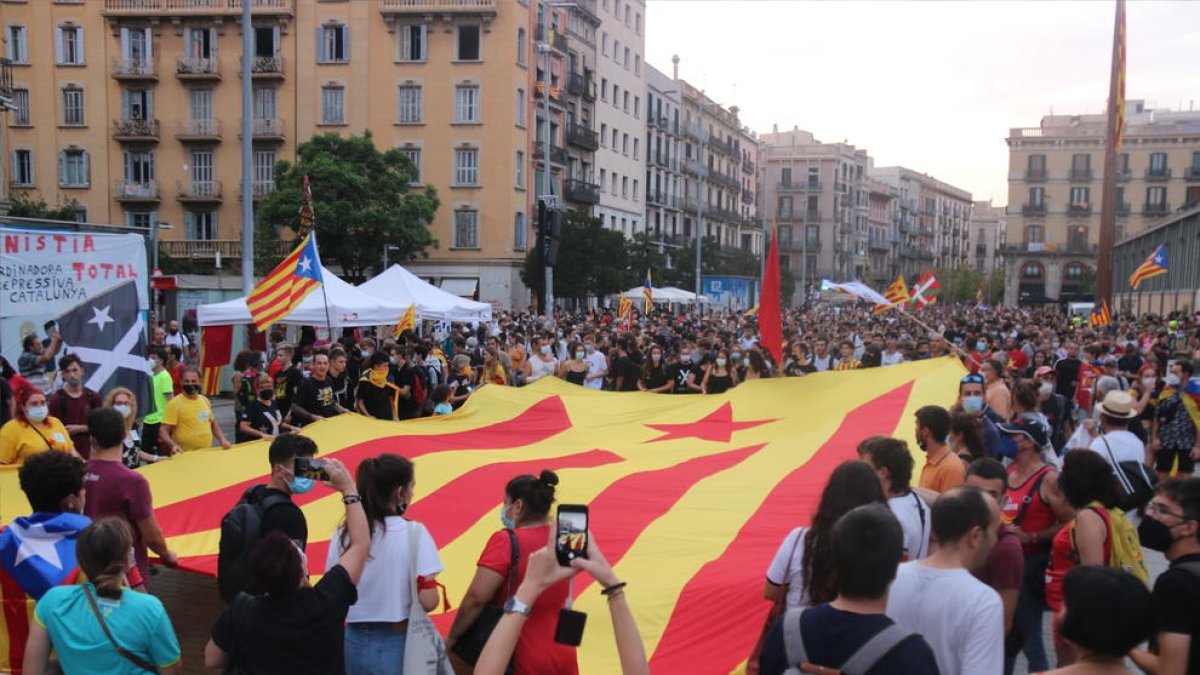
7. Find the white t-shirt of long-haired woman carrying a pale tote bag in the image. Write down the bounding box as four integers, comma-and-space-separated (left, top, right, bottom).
325, 515, 443, 623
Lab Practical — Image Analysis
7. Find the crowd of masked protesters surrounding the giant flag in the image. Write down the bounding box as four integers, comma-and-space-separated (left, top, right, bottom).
0, 304, 1200, 675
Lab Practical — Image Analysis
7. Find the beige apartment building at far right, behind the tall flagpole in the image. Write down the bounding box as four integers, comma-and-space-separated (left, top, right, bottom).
1003, 100, 1200, 305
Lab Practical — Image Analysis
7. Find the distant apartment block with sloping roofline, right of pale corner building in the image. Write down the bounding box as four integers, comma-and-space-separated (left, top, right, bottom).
871, 167, 974, 276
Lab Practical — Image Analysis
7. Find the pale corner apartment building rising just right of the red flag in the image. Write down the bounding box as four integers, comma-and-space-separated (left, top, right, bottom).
758, 127, 872, 297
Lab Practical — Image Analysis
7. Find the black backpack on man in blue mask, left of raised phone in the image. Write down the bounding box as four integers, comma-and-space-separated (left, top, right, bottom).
217, 485, 292, 603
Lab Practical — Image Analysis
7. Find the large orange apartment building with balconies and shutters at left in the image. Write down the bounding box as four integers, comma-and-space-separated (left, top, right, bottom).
0, 0, 535, 306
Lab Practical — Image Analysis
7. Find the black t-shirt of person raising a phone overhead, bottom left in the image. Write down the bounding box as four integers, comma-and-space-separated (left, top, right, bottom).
212, 565, 359, 675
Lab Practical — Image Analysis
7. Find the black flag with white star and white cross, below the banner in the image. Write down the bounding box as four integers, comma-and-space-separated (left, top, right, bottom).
59, 281, 154, 417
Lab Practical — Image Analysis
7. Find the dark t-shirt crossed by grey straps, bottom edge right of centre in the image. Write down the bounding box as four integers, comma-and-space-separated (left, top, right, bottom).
760, 604, 938, 675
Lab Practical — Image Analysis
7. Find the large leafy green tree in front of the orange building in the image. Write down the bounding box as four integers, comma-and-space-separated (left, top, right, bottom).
254, 131, 439, 280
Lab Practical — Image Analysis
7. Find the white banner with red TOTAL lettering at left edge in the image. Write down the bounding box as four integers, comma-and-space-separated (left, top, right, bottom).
0, 227, 150, 368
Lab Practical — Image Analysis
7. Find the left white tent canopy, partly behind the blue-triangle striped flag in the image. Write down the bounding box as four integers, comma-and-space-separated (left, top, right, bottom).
196, 267, 408, 328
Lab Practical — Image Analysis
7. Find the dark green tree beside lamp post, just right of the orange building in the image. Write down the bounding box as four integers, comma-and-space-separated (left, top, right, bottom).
521, 211, 624, 303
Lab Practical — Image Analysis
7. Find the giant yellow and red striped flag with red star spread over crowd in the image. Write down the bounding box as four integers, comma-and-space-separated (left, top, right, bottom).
0, 358, 965, 674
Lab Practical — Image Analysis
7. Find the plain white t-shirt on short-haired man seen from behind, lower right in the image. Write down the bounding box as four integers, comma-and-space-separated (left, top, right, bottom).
887, 562, 1004, 675
